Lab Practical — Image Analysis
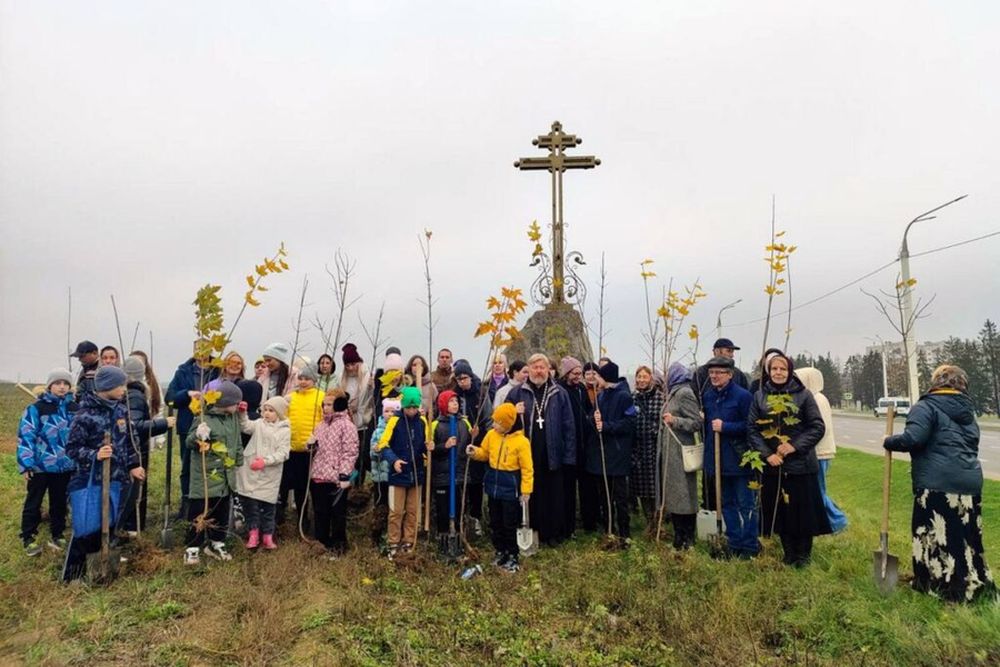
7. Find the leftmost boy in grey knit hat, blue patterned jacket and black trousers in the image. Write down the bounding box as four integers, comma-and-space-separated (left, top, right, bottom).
17, 368, 77, 556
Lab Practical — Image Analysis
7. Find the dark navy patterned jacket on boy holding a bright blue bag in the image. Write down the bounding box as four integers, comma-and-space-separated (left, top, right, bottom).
66, 394, 140, 491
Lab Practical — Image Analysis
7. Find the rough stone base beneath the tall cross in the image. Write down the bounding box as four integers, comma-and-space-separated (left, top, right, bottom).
506, 303, 596, 364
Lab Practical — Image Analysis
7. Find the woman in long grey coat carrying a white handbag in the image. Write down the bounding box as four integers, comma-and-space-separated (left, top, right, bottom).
660, 361, 702, 550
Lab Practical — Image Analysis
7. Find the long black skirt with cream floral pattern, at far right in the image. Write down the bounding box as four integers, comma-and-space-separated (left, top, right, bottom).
912, 489, 996, 602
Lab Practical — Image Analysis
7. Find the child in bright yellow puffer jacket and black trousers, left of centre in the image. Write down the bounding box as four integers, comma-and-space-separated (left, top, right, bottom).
276, 365, 323, 531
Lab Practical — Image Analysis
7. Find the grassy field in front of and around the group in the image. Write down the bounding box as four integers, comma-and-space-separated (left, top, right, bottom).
0, 386, 1000, 666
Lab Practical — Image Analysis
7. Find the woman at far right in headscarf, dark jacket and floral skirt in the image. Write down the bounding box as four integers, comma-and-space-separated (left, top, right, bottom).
883, 365, 996, 602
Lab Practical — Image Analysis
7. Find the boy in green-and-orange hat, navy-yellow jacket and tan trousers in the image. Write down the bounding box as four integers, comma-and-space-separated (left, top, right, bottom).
377, 387, 433, 559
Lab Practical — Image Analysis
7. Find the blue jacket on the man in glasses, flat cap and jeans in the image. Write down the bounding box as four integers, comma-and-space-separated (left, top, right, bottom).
701, 382, 753, 477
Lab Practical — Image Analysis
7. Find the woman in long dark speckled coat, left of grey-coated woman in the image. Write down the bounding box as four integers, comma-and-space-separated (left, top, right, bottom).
628, 366, 665, 531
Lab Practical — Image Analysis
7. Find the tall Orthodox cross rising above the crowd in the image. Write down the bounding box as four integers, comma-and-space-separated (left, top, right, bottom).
514, 121, 601, 303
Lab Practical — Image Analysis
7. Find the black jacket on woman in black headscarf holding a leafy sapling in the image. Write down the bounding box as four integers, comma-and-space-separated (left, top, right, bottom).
747, 373, 826, 475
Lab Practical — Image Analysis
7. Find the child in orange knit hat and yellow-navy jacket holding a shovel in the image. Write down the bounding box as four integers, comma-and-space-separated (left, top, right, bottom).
465, 403, 535, 572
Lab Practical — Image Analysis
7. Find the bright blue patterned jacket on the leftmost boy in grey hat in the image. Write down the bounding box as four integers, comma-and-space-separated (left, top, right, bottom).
17, 392, 77, 473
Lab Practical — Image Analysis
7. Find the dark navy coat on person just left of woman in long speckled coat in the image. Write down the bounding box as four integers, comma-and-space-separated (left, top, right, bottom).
587, 380, 638, 477
